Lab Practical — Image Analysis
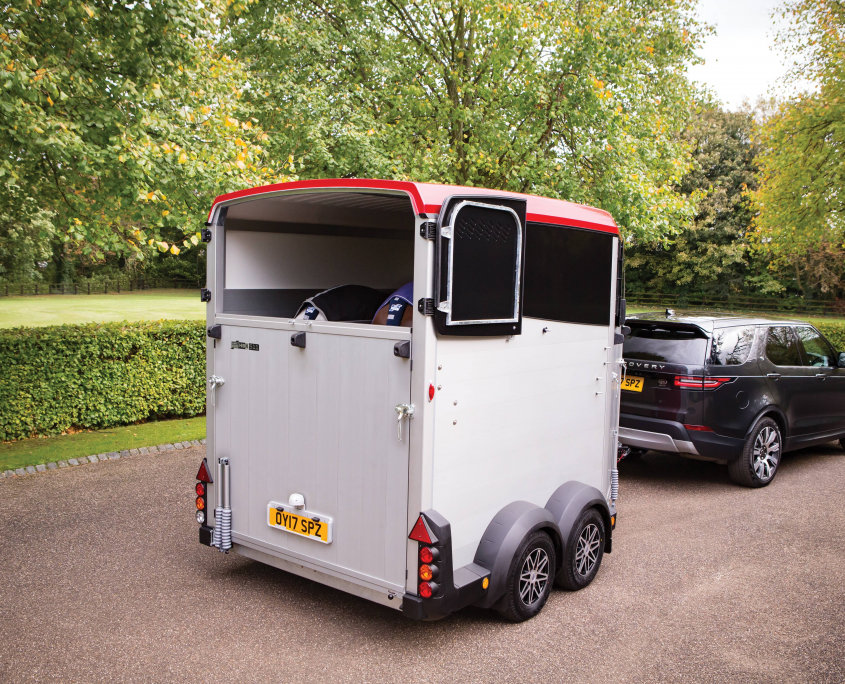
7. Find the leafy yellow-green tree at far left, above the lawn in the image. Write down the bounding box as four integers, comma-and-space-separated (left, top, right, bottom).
0, 0, 280, 272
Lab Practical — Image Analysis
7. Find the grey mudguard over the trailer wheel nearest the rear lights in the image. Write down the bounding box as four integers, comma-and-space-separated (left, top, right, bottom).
473, 501, 562, 608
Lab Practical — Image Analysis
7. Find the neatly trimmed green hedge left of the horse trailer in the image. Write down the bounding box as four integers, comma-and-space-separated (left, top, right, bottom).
0, 321, 205, 441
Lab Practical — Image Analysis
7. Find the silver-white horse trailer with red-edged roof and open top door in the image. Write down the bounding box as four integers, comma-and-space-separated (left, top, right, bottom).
196, 179, 624, 621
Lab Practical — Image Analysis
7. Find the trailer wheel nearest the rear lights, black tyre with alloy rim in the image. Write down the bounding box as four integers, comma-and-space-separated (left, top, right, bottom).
496, 532, 556, 622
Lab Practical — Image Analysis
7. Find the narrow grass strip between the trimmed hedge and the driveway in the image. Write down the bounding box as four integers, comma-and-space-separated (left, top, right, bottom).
0, 416, 205, 472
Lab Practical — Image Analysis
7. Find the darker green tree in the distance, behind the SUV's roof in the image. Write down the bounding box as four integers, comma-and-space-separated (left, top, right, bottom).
626, 104, 782, 298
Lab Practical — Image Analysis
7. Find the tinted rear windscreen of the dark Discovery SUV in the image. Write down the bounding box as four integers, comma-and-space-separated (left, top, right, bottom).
622, 324, 708, 366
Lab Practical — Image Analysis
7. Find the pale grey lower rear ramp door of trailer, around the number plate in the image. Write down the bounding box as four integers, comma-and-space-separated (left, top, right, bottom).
209, 323, 411, 593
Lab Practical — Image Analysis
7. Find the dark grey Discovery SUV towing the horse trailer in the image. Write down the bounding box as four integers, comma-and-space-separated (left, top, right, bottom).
619, 311, 845, 487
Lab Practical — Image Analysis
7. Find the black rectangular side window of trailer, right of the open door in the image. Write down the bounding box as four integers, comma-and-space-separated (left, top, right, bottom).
523, 223, 614, 325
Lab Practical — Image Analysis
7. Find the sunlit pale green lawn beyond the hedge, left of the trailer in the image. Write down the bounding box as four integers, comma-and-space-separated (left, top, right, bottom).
0, 290, 205, 328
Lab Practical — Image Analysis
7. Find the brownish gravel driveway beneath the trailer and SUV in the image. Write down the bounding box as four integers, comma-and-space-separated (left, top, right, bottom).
0, 445, 845, 683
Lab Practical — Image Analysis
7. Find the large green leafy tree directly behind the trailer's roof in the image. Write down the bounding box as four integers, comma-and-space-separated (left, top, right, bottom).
229, 0, 698, 242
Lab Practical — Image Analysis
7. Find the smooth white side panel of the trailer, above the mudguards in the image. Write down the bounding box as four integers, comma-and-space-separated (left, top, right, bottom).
432, 318, 615, 568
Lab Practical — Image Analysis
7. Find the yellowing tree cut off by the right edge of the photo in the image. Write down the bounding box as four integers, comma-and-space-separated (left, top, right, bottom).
755, 0, 845, 297
